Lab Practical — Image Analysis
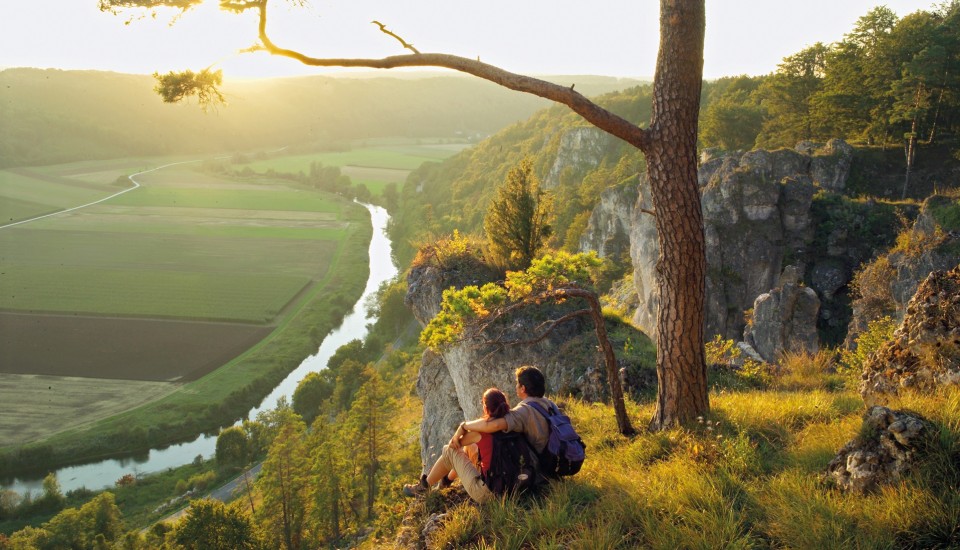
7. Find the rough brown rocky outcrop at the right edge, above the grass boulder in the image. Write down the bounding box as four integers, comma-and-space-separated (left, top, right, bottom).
860, 266, 960, 405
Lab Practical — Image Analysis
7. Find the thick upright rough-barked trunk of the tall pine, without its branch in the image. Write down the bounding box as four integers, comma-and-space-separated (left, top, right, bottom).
644, 0, 709, 430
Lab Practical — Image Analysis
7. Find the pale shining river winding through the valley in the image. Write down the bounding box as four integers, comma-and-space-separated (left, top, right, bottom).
0, 204, 397, 494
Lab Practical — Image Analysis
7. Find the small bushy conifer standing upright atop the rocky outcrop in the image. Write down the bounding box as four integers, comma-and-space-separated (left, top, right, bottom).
483, 158, 551, 270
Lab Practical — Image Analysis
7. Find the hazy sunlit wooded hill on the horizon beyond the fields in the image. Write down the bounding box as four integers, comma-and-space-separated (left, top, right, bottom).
0, 69, 637, 167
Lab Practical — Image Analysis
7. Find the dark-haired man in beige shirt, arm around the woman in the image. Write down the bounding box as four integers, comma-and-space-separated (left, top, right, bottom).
403, 366, 556, 500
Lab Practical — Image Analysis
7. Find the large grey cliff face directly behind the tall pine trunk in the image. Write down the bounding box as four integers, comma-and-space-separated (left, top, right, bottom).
630, 140, 852, 338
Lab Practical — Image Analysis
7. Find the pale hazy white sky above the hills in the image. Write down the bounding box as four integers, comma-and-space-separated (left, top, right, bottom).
0, 0, 932, 78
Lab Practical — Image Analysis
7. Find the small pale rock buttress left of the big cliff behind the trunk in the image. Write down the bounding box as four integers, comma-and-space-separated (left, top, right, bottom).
580, 185, 637, 258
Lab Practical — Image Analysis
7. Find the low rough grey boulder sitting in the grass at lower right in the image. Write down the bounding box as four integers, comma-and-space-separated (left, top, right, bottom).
826, 407, 934, 494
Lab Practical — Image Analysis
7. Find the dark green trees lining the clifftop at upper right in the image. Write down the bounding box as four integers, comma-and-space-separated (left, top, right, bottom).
700, 0, 960, 183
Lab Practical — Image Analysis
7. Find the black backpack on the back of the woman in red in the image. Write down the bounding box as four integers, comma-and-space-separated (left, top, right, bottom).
481, 432, 537, 495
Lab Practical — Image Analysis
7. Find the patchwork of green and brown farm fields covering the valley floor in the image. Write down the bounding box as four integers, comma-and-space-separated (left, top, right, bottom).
0, 143, 454, 458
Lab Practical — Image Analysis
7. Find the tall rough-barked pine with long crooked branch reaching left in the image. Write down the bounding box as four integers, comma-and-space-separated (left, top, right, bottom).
100, 0, 709, 429
